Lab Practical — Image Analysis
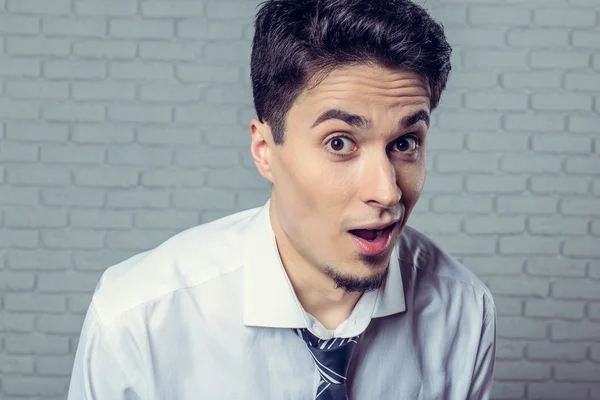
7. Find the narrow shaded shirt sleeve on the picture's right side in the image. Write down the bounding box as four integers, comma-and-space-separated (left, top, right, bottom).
468, 300, 496, 400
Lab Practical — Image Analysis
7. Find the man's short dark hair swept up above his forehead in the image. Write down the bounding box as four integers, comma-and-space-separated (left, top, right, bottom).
251, 0, 452, 144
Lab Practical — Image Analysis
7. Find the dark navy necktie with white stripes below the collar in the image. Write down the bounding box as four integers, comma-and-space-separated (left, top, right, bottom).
294, 329, 359, 400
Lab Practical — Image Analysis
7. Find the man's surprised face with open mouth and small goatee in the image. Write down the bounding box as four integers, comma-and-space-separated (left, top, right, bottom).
255, 66, 430, 292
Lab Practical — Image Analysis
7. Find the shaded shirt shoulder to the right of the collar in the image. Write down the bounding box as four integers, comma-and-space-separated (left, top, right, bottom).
399, 226, 495, 313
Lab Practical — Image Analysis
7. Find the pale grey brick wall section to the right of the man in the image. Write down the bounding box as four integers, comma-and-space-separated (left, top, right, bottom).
422, 0, 600, 400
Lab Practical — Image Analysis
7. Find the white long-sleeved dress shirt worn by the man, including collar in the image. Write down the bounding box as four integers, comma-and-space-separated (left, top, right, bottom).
68, 202, 496, 400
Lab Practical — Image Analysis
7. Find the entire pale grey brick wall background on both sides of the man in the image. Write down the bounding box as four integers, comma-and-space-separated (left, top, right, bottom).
0, 0, 600, 400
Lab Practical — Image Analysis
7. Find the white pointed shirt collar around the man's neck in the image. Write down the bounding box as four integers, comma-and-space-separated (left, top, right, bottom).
244, 201, 406, 328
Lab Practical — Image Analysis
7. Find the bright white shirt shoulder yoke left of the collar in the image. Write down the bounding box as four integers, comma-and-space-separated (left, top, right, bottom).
92, 208, 259, 324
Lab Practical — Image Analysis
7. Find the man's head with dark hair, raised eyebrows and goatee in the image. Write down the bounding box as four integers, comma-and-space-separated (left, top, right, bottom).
251, 0, 451, 292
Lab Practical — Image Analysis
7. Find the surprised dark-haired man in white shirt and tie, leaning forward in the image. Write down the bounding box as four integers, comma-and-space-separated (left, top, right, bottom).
69, 0, 495, 400
